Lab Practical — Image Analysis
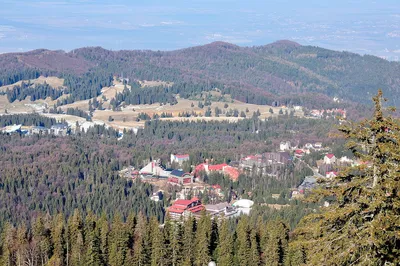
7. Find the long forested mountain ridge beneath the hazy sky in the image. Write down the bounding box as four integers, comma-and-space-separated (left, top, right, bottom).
0, 41, 400, 106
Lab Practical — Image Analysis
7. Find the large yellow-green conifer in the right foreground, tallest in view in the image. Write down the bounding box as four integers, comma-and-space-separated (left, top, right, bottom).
292, 90, 400, 265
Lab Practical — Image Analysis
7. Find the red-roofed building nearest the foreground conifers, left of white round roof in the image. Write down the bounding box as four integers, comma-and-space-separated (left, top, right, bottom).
167, 197, 204, 220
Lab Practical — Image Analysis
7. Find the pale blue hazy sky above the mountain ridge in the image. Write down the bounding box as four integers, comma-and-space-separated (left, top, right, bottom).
0, 0, 400, 59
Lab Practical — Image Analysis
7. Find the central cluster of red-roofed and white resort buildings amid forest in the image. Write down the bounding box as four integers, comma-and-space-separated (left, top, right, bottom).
134, 154, 253, 220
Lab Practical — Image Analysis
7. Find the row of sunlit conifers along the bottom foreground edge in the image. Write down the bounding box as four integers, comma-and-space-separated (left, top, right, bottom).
0, 210, 296, 266
